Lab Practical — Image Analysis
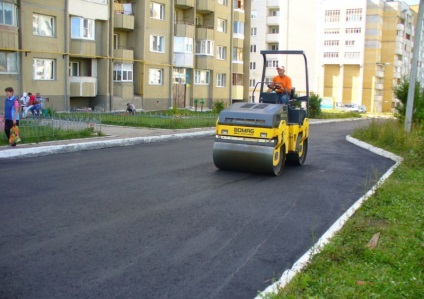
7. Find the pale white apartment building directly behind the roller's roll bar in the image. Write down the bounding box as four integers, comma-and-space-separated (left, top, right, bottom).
249, 0, 319, 101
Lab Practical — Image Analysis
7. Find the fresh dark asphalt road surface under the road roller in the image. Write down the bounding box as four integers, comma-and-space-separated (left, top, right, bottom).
0, 121, 393, 298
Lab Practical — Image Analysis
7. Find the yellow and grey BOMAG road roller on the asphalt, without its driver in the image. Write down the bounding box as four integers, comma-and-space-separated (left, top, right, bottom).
213, 50, 309, 176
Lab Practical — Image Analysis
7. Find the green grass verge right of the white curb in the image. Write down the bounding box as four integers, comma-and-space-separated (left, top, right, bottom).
265, 120, 424, 299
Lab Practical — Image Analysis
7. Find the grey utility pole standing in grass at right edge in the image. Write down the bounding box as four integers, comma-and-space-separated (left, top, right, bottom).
405, 0, 424, 133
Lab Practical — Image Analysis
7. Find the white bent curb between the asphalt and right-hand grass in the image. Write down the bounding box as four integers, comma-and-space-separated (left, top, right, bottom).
255, 135, 403, 299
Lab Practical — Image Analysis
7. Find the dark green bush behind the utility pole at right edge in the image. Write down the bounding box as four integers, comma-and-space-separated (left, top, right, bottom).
393, 76, 424, 123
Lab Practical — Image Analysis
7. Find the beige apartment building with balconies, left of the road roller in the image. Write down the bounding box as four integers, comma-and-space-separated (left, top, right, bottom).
0, 0, 250, 111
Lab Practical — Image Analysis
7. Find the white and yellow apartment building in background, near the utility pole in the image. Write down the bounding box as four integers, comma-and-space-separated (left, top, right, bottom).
321, 0, 423, 112
